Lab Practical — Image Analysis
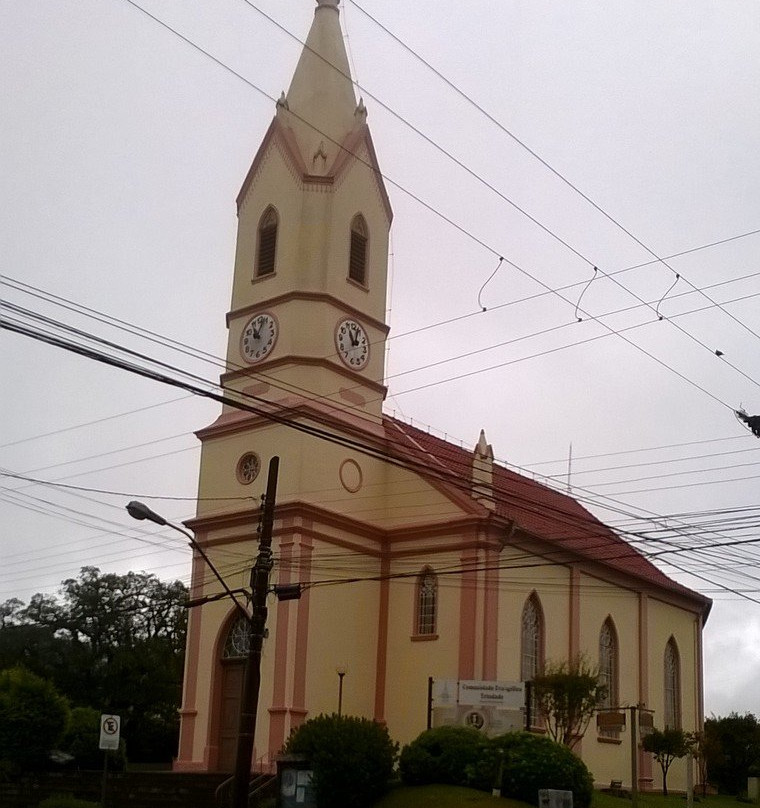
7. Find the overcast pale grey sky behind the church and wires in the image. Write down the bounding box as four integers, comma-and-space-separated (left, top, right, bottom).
0, 0, 760, 714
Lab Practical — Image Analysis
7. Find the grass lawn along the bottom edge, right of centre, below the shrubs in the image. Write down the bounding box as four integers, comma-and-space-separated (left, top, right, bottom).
374, 786, 746, 808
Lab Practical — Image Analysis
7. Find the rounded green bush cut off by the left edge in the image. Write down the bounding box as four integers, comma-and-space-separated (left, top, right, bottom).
0, 668, 69, 772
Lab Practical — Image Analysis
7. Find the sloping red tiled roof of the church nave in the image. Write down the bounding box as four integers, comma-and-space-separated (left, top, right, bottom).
384, 416, 712, 617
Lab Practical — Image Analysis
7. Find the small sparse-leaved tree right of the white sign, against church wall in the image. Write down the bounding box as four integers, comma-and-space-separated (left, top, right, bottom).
531, 656, 607, 749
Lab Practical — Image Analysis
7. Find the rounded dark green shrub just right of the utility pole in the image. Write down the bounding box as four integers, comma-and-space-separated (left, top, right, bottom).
284, 715, 398, 808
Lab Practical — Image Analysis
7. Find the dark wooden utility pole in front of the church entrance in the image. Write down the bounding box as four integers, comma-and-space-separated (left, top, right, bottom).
232, 457, 280, 808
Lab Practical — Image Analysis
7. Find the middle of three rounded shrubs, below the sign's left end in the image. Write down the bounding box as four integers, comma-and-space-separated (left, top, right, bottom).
399, 726, 487, 786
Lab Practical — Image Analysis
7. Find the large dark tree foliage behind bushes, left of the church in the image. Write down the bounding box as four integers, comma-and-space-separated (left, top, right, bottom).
0, 567, 187, 762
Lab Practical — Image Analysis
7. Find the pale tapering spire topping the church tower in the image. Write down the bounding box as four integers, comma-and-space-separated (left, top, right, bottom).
286, 0, 363, 174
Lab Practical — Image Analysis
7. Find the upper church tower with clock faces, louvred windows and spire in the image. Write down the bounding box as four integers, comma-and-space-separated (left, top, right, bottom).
222, 0, 392, 420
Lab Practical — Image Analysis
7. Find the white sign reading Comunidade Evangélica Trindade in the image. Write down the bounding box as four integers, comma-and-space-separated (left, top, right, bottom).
430, 679, 525, 735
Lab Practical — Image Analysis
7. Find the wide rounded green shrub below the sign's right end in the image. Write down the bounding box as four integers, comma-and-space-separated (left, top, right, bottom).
471, 732, 593, 808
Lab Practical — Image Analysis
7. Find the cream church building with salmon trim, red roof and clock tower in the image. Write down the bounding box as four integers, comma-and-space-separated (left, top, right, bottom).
175, 0, 710, 788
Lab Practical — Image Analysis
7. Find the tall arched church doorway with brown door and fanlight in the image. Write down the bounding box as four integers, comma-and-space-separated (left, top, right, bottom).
218, 615, 251, 772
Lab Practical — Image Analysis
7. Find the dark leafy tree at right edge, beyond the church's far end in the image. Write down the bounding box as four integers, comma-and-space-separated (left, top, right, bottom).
704, 713, 760, 794
